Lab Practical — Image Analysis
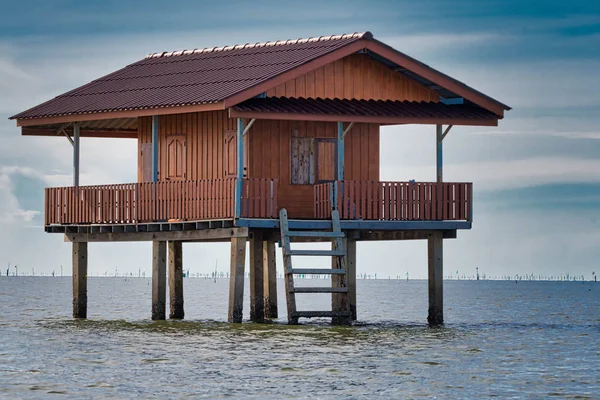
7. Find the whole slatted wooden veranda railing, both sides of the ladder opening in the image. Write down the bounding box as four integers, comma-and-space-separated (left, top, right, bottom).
44, 178, 473, 227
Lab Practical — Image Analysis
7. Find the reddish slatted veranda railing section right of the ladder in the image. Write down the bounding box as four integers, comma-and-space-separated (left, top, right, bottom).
314, 181, 473, 221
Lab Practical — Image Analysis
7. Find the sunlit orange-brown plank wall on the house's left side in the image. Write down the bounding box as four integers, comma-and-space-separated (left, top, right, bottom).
138, 111, 236, 182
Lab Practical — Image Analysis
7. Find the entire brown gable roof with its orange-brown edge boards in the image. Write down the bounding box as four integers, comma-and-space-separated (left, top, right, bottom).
11, 32, 510, 125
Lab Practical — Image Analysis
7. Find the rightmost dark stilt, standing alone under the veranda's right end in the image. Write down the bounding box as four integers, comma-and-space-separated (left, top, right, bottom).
427, 231, 444, 326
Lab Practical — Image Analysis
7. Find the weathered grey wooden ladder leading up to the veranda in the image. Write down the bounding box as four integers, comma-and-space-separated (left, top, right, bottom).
279, 208, 352, 324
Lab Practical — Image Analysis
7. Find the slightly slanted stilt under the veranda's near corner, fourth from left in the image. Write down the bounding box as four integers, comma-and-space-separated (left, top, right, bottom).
228, 237, 246, 323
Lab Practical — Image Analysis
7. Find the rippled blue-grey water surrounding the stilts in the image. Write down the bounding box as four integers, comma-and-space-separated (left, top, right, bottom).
0, 277, 600, 399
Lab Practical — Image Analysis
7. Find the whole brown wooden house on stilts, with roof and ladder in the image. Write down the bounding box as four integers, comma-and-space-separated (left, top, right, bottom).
12, 32, 510, 325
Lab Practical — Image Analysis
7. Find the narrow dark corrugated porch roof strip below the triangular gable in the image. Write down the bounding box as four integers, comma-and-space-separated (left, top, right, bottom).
232, 97, 499, 121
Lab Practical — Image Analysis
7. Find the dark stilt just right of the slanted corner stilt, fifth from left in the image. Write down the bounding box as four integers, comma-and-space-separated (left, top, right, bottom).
250, 230, 265, 322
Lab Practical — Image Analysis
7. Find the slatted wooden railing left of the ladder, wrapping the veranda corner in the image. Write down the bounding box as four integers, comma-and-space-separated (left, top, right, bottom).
45, 179, 278, 225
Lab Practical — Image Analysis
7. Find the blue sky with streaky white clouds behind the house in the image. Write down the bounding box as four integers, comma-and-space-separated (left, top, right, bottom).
0, 0, 600, 279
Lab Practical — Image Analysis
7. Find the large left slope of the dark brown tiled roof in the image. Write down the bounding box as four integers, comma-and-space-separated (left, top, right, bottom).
11, 32, 372, 119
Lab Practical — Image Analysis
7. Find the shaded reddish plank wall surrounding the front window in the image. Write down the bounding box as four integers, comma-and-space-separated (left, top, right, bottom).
248, 120, 379, 218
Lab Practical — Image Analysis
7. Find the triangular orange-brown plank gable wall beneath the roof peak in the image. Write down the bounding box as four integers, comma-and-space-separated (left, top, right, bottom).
267, 54, 439, 102
